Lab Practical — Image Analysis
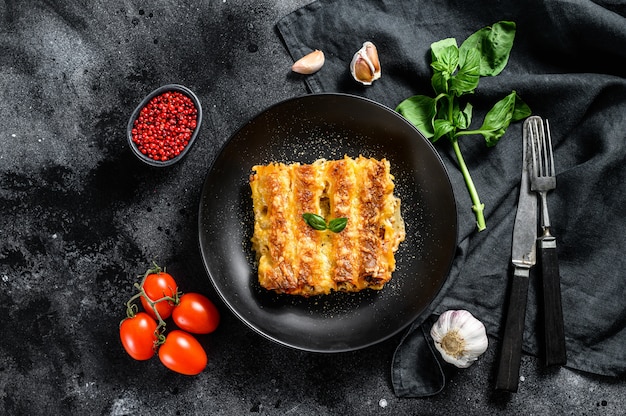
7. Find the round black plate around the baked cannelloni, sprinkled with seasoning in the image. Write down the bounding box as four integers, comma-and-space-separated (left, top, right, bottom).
199, 94, 457, 352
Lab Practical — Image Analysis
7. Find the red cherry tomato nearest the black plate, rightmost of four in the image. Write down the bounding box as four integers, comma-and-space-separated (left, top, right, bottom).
172, 293, 220, 334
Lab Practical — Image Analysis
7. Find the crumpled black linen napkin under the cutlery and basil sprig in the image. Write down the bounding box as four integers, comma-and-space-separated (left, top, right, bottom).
277, 0, 626, 397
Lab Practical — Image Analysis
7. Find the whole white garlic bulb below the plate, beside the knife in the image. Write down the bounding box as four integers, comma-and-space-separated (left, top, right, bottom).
430, 310, 489, 368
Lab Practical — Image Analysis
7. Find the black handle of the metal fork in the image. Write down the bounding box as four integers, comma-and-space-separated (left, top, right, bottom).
539, 235, 567, 366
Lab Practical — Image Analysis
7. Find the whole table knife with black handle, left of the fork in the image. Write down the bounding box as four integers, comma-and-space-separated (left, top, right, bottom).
496, 121, 537, 392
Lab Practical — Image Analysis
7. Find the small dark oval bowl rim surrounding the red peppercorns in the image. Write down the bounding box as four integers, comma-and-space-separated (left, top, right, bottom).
126, 84, 202, 167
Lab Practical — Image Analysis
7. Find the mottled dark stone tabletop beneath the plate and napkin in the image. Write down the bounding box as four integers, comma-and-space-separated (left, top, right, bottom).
0, 0, 626, 415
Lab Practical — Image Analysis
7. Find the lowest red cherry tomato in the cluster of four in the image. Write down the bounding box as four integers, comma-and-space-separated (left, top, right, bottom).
159, 329, 208, 376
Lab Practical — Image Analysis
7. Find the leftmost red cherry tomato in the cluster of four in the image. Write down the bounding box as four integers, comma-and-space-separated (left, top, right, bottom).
120, 312, 157, 360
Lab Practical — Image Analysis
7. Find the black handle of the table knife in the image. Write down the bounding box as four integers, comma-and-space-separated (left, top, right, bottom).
496, 267, 530, 393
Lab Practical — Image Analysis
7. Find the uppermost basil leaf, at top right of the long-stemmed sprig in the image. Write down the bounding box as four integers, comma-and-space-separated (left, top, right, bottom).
459, 21, 516, 77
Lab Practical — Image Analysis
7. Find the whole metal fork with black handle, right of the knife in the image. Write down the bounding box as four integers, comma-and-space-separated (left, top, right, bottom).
530, 116, 567, 365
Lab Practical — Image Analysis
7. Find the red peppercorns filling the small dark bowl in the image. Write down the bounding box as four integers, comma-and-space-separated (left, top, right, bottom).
131, 91, 198, 162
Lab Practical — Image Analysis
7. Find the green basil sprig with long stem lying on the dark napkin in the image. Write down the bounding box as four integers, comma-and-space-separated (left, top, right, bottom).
396, 21, 531, 231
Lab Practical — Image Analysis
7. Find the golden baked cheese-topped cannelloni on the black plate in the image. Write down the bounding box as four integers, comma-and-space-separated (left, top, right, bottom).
250, 156, 405, 296
